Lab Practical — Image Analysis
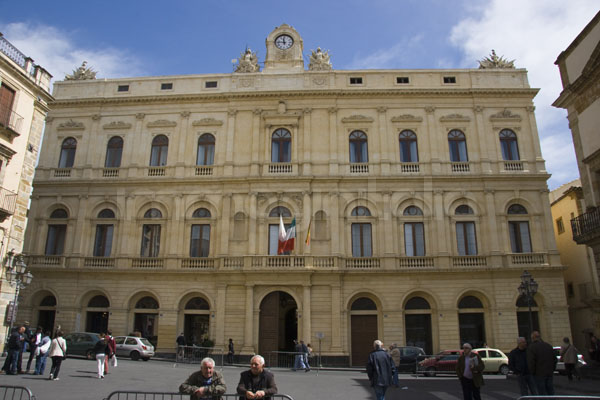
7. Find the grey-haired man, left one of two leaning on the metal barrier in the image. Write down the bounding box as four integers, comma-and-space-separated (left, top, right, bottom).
179, 357, 227, 400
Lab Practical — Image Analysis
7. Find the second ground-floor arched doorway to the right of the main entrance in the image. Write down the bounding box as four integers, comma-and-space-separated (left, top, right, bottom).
404, 296, 433, 354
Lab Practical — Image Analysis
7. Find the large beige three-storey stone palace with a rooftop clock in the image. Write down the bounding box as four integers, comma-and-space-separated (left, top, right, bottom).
20, 25, 570, 365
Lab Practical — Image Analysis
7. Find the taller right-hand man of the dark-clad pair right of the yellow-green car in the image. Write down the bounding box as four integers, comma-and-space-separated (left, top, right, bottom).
527, 331, 557, 396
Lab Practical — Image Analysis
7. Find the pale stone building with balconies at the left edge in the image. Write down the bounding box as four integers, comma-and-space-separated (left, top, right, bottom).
0, 33, 52, 347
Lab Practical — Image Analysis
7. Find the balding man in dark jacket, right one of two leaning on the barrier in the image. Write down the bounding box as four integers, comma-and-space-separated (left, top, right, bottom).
237, 355, 277, 400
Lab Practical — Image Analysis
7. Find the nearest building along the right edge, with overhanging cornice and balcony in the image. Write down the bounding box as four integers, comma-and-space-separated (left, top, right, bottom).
553, 12, 600, 344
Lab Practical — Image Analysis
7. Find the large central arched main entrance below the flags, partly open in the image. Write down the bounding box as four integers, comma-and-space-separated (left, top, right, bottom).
258, 291, 298, 365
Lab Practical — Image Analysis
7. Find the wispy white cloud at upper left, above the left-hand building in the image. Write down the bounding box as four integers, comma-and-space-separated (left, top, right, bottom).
2, 22, 143, 81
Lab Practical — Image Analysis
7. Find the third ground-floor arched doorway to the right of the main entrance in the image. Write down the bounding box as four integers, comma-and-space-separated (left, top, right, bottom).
458, 296, 486, 348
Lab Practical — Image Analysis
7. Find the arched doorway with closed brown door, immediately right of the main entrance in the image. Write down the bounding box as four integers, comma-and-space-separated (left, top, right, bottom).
350, 297, 378, 366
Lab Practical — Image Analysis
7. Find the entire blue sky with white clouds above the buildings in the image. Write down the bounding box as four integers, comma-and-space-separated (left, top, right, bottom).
0, 0, 600, 189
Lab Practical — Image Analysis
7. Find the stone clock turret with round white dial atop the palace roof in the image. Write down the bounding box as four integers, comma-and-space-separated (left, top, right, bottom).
263, 24, 304, 72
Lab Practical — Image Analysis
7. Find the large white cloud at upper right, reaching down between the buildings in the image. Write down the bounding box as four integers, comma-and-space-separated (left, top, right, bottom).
451, 0, 598, 188
